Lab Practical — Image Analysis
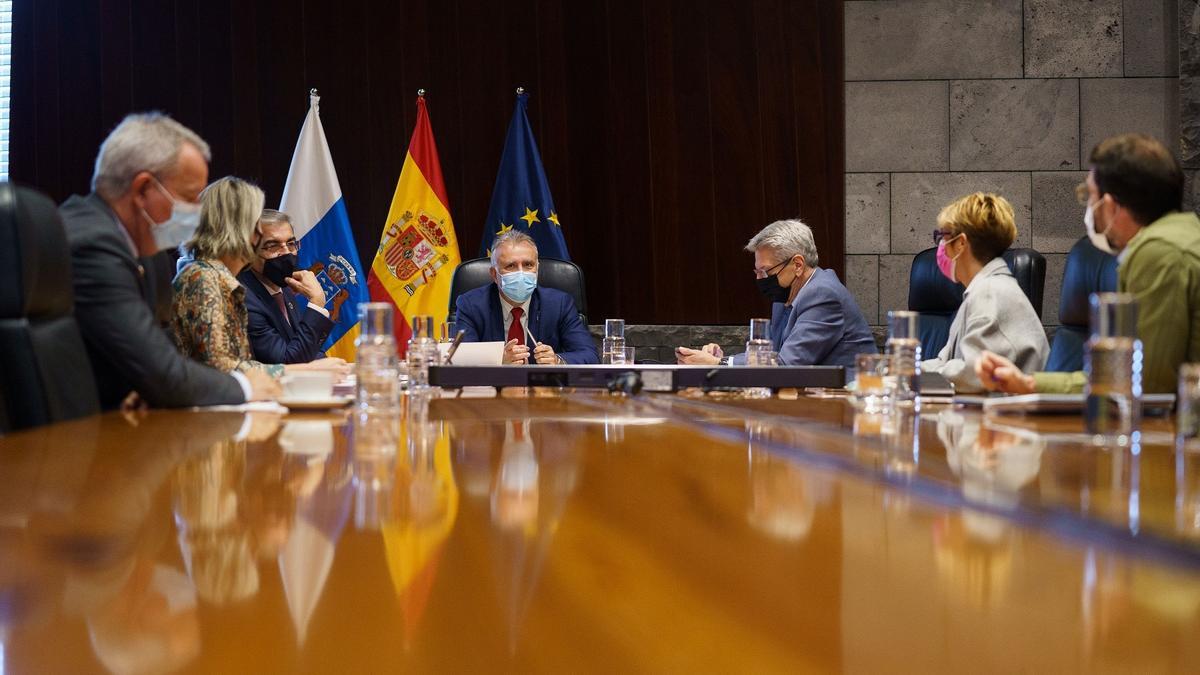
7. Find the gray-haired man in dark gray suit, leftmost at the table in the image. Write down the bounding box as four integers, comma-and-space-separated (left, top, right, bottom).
59, 113, 278, 410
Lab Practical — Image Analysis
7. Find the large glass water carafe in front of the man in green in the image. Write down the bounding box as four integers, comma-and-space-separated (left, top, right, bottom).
1084, 293, 1142, 443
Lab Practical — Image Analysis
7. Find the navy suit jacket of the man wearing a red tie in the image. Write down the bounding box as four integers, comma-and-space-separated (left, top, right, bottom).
455, 283, 600, 364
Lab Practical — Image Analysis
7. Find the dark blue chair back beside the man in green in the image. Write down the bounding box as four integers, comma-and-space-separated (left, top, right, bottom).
1046, 237, 1117, 372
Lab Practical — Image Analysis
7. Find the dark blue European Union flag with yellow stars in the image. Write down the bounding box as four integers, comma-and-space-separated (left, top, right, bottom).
479, 91, 571, 261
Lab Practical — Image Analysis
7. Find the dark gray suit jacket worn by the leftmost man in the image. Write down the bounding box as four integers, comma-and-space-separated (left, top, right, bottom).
59, 195, 246, 410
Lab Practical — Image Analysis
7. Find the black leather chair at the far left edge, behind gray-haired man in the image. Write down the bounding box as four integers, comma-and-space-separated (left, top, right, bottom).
0, 183, 100, 431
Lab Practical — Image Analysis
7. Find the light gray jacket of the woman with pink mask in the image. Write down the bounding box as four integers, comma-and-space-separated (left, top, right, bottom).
920, 258, 1050, 392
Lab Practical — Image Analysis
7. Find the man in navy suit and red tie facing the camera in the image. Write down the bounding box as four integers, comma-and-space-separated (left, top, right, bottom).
455, 232, 600, 364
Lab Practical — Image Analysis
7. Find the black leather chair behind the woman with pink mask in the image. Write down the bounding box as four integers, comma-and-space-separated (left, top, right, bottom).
908, 247, 1046, 358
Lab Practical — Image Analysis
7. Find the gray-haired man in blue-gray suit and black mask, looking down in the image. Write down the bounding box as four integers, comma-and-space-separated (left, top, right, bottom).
676, 220, 877, 368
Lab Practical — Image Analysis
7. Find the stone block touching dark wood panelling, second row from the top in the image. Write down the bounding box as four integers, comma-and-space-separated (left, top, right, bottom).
846, 82, 949, 173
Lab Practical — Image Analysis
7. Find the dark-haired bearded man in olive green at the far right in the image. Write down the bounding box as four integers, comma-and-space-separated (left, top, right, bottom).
976, 133, 1200, 394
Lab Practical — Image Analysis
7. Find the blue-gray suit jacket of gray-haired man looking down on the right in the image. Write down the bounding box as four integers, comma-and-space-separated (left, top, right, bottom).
733, 268, 878, 368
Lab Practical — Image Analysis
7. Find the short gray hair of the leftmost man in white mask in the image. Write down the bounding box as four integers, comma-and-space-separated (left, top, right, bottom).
91, 112, 212, 199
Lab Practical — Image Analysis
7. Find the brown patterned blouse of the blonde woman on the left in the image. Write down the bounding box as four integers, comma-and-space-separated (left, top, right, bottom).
170, 261, 283, 377
